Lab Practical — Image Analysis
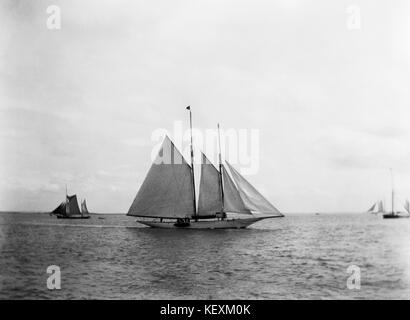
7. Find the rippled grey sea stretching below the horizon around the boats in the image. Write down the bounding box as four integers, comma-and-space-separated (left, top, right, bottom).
0, 213, 410, 299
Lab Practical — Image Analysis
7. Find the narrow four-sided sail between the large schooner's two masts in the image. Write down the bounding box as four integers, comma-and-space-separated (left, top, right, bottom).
197, 153, 222, 217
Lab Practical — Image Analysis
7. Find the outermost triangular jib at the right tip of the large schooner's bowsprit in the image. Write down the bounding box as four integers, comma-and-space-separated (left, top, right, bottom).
226, 161, 282, 215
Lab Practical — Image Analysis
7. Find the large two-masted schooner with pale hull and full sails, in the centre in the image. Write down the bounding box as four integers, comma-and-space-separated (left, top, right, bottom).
127, 108, 283, 229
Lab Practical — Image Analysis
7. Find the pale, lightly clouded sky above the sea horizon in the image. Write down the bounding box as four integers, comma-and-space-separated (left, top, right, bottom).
0, 0, 410, 213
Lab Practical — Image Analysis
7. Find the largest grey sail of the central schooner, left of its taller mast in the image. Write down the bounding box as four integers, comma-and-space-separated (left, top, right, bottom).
127, 137, 194, 218
